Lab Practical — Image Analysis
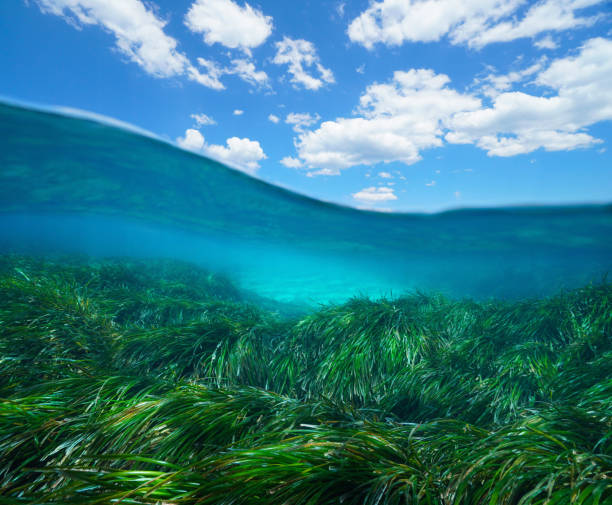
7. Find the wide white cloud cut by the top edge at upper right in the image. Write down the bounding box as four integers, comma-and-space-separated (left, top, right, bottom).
348, 0, 605, 49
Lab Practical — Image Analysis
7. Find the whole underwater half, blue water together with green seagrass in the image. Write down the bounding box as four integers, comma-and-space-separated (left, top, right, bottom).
0, 103, 612, 505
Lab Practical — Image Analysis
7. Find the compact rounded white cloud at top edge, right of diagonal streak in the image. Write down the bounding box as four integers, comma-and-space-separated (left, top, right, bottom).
185, 0, 272, 53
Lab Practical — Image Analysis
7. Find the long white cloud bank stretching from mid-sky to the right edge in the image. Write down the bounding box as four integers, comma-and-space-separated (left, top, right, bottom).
295, 38, 612, 171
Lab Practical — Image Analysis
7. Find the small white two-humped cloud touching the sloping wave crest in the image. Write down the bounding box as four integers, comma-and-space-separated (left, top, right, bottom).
176, 128, 267, 175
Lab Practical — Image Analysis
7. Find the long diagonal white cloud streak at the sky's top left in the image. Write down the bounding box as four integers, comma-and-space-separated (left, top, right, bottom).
36, 0, 230, 89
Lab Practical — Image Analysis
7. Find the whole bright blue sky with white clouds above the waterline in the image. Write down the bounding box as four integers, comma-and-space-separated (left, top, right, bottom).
0, 0, 612, 212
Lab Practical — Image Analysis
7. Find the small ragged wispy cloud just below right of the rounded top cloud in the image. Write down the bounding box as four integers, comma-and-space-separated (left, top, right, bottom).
273, 37, 335, 90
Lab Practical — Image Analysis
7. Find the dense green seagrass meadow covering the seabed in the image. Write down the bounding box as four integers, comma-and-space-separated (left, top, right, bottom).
0, 254, 612, 505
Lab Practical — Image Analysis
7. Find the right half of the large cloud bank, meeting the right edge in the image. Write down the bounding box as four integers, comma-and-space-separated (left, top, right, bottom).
446, 38, 612, 156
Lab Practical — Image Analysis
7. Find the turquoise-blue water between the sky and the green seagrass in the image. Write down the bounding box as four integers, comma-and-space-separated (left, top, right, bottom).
0, 98, 612, 305
